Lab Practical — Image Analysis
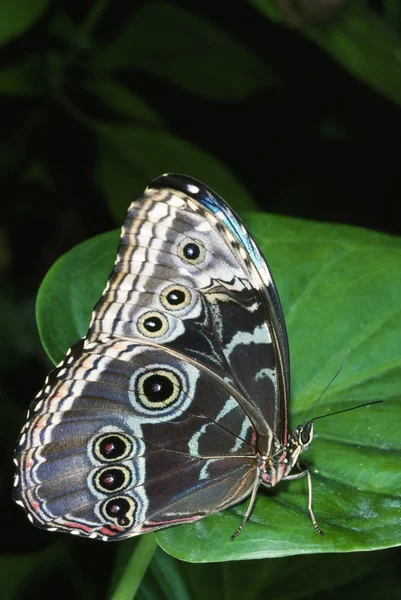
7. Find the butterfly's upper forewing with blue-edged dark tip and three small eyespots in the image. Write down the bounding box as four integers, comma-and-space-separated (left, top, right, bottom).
89, 175, 289, 445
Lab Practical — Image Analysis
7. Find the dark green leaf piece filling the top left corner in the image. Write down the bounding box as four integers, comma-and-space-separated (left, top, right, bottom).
0, 0, 49, 46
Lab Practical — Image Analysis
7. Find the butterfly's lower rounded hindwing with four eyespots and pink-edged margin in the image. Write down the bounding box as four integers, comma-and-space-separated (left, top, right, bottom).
14, 338, 256, 539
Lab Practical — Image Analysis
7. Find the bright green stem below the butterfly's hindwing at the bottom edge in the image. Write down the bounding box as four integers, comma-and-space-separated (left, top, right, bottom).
110, 533, 157, 600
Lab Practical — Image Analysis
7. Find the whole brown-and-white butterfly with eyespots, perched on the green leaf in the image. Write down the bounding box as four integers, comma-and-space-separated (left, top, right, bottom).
13, 174, 320, 541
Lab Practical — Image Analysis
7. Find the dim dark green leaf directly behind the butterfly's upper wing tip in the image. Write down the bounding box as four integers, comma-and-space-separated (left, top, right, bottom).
93, 123, 256, 222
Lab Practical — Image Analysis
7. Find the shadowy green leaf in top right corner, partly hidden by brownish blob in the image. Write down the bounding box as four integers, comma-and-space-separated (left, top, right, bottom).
249, 0, 401, 104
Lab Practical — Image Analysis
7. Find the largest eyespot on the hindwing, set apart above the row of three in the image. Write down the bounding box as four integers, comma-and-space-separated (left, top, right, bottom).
135, 369, 182, 410
